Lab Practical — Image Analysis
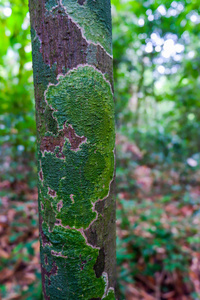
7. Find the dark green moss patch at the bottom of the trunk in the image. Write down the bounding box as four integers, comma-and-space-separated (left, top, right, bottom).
41, 223, 105, 300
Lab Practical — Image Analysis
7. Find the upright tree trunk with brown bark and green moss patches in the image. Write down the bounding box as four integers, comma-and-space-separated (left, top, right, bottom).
29, 0, 116, 300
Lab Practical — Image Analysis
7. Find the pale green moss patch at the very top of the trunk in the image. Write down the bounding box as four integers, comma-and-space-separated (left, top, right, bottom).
46, 0, 112, 54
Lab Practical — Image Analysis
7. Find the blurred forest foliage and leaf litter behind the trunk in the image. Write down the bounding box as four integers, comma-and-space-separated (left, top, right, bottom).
0, 0, 200, 300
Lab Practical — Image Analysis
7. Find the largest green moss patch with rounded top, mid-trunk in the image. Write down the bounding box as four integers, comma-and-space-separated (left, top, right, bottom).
41, 66, 115, 228
